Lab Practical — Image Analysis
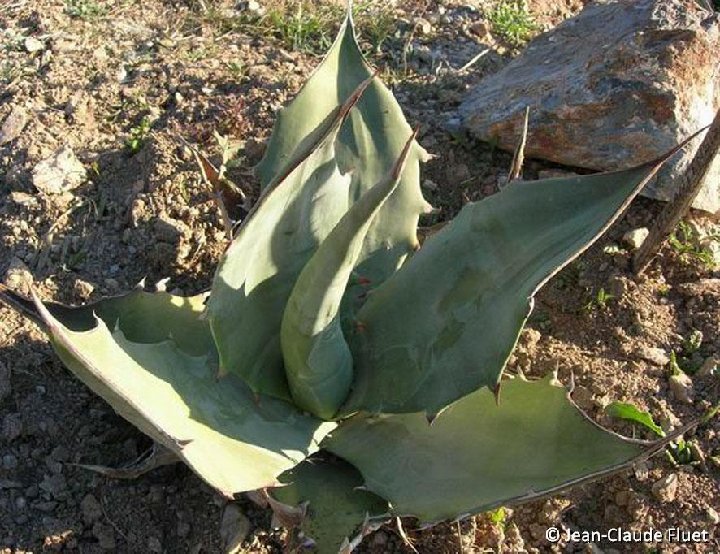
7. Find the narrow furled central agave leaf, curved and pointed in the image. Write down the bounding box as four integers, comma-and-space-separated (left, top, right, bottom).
281, 134, 415, 419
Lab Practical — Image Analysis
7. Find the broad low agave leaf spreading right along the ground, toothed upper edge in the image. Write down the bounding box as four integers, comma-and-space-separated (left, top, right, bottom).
328, 378, 654, 522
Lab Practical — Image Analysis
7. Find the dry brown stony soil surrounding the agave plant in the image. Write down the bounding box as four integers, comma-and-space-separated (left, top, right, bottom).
0, 0, 720, 553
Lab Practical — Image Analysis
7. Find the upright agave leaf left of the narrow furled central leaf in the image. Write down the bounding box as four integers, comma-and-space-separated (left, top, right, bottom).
207, 80, 370, 400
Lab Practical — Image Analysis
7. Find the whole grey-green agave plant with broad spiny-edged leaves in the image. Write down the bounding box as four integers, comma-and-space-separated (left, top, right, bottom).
0, 9, 696, 552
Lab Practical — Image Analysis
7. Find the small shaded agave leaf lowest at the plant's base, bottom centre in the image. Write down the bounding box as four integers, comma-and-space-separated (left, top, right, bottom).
270, 454, 388, 554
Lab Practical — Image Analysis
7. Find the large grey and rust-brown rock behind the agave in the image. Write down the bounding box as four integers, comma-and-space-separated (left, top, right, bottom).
460, 0, 720, 212
